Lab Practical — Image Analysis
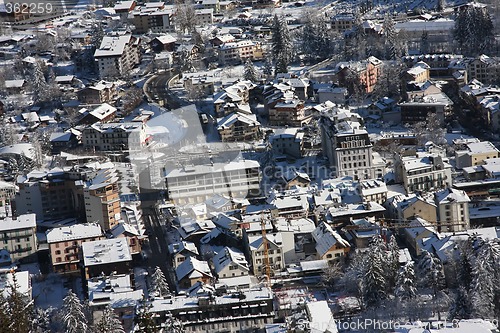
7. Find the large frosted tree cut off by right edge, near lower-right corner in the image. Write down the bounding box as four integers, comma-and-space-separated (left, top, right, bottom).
470, 240, 500, 318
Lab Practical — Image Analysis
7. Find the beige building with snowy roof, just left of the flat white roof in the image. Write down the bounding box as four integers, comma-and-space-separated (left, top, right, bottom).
46, 223, 105, 273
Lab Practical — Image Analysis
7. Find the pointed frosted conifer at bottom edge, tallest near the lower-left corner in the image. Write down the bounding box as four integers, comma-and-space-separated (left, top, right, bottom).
62, 290, 89, 333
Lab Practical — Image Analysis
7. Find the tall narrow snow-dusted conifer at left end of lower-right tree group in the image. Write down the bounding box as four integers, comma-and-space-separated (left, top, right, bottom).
362, 236, 387, 307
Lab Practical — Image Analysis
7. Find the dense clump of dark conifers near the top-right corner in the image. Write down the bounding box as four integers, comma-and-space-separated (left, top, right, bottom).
454, 6, 494, 56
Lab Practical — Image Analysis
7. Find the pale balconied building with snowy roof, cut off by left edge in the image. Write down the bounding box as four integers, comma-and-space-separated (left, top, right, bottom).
0, 214, 38, 261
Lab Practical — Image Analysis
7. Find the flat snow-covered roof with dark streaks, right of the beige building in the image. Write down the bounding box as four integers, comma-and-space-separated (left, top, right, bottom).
82, 238, 132, 267
